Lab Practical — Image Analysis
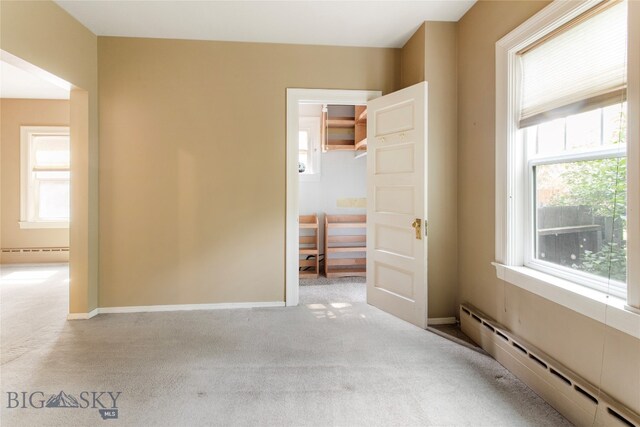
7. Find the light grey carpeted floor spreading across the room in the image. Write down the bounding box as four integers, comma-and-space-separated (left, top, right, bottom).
0, 267, 569, 426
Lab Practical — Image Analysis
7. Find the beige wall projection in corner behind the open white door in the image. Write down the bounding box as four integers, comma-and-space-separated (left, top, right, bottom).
401, 21, 458, 318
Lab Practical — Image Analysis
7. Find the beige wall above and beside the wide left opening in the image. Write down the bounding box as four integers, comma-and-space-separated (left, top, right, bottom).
0, 1, 98, 313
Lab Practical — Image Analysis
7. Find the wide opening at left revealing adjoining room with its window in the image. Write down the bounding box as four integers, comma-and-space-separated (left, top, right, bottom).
0, 51, 72, 318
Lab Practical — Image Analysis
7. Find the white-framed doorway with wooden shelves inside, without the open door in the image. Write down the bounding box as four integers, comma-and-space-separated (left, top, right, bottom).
286, 89, 381, 306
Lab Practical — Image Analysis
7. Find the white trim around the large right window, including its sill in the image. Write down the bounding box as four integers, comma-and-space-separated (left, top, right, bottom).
493, 0, 640, 338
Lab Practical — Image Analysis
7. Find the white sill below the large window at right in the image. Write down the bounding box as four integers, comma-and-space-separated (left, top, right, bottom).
492, 262, 640, 339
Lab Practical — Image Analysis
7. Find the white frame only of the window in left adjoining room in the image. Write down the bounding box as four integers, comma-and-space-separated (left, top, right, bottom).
19, 126, 71, 229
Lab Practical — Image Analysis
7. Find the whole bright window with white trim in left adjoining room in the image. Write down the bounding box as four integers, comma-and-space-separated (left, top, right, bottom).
20, 126, 70, 228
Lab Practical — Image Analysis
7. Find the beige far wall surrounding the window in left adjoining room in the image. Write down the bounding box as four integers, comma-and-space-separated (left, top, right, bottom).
0, 99, 69, 263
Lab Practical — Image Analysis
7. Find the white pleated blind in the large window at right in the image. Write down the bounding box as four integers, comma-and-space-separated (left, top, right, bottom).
520, 1, 627, 127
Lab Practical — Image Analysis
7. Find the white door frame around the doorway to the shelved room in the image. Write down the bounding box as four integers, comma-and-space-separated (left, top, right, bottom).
285, 88, 382, 307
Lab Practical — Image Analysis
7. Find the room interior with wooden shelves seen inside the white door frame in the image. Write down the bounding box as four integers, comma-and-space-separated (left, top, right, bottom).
298, 103, 367, 303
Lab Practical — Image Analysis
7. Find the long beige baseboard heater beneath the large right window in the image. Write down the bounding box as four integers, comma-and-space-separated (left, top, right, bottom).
460, 304, 640, 427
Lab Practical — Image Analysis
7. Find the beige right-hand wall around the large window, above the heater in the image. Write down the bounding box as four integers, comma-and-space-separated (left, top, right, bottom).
458, 1, 640, 412
